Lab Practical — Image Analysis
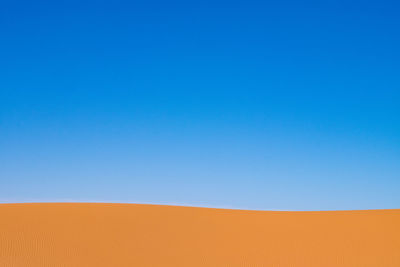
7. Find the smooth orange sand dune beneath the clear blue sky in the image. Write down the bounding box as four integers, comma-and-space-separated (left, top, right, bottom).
0, 203, 400, 267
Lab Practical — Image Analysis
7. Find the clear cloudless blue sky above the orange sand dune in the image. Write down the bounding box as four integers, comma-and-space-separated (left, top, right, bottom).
0, 0, 400, 210
